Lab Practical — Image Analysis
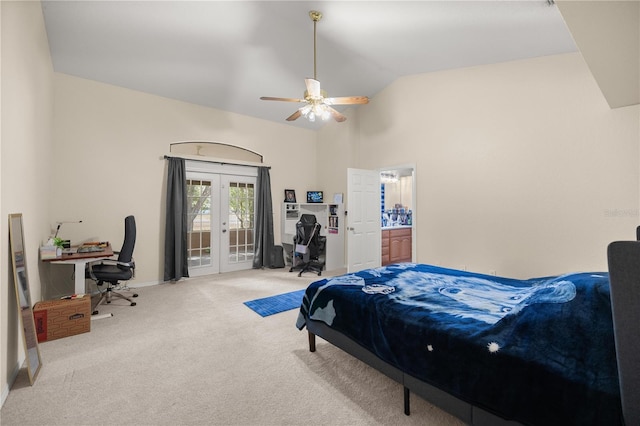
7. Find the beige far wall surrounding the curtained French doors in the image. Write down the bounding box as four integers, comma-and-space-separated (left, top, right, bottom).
51, 74, 317, 284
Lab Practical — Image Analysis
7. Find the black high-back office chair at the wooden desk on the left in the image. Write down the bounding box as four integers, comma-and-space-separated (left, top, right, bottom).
85, 216, 138, 315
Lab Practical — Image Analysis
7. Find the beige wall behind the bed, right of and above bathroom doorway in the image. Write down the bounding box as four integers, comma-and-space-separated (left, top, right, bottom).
318, 54, 640, 277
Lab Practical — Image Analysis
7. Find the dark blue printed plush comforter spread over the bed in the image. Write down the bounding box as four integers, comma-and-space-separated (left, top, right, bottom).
296, 263, 622, 425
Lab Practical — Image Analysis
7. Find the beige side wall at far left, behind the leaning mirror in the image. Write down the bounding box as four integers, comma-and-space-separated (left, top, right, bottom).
0, 1, 54, 402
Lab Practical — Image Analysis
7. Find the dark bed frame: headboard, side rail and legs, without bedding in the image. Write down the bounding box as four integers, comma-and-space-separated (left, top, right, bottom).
306, 241, 640, 426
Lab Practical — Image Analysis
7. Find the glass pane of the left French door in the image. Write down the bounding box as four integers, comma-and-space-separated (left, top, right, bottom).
187, 179, 211, 268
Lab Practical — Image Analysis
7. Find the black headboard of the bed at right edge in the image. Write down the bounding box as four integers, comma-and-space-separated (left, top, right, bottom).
607, 241, 640, 425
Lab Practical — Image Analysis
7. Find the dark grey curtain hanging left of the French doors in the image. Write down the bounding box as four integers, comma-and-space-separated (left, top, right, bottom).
164, 158, 189, 281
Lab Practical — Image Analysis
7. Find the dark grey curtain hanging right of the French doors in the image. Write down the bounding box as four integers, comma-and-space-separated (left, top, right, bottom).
253, 167, 274, 269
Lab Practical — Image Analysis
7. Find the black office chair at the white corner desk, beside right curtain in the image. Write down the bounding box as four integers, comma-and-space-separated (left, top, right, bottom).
289, 214, 327, 277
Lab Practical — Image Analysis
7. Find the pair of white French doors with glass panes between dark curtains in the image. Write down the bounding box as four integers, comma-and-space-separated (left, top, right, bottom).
187, 163, 256, 277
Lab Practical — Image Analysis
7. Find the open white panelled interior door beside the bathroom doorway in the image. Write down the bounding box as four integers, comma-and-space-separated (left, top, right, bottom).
347, 169, 382, 272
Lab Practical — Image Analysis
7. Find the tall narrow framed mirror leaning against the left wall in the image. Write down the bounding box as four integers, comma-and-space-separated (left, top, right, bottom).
9, 213, 42, 385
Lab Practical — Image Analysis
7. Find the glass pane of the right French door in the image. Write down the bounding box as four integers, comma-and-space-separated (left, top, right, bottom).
229, 182, 255, 263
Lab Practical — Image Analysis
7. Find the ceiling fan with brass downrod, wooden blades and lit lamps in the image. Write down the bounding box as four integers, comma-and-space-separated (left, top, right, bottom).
260, 10, 369, 122
